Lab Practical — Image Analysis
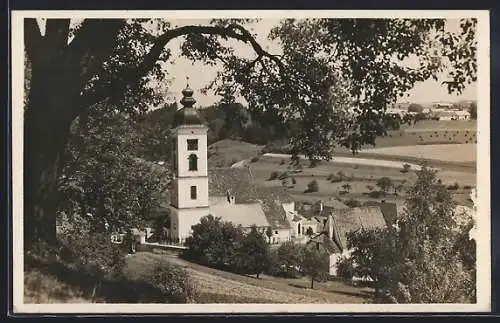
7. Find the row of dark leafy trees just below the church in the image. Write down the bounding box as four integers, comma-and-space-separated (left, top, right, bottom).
184, 215, 328, 288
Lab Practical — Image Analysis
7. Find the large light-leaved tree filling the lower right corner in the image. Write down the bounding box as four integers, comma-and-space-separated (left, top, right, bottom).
348, 167, 475, 303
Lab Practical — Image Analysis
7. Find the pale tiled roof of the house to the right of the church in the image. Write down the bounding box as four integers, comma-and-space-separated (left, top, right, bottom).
332, 206, 386, 249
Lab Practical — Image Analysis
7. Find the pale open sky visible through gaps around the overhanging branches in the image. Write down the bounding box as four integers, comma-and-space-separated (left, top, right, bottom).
35, 19, 477, 106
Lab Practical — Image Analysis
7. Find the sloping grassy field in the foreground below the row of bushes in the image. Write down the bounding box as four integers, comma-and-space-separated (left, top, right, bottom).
126, 252, 372, 304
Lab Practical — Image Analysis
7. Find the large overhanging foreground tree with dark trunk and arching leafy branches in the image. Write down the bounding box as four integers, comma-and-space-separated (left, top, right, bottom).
24, 18, 477, 244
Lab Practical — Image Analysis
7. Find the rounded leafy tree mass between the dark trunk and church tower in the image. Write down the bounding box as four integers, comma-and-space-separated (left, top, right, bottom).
59, 105, 168, 231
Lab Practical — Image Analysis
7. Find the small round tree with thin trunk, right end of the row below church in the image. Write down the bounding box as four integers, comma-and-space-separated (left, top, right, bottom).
301, 243, 329, 289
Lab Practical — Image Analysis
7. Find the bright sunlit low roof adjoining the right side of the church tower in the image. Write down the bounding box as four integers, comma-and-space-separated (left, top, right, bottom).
209, 203, 269, 228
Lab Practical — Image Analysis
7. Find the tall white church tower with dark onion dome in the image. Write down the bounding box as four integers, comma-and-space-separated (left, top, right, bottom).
170, 80, 209, 243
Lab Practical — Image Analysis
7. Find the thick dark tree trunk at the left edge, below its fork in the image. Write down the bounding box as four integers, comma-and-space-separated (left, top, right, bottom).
24, 60, 73, 247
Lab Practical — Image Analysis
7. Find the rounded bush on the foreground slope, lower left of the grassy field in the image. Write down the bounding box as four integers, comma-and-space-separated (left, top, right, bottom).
144, 262, 198, 303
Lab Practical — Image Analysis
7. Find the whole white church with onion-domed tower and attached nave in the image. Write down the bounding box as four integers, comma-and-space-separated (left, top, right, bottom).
169, 85, 295, 243
